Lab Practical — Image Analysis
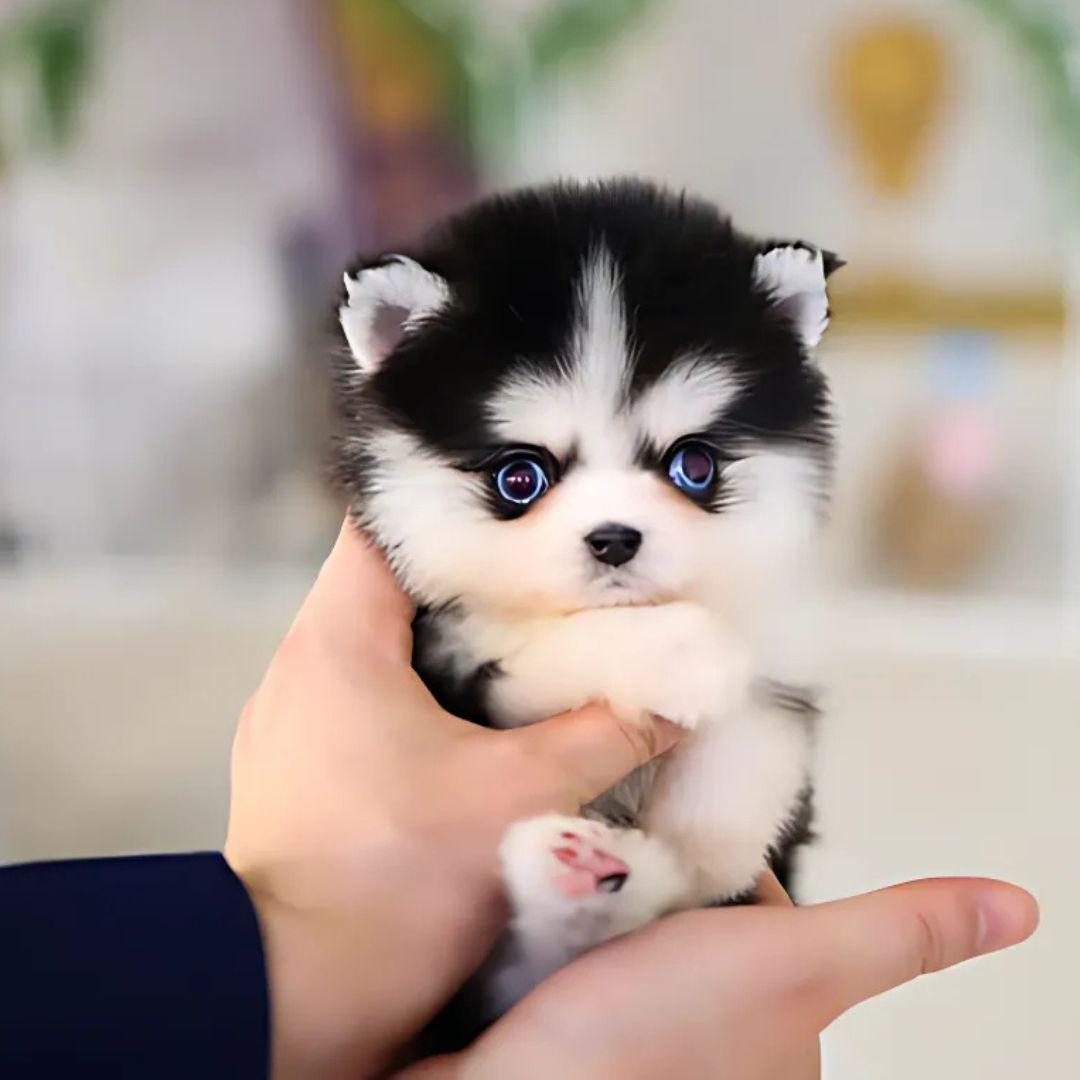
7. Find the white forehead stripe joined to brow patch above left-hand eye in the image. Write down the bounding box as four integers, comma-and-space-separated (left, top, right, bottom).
488, 247, 633, 463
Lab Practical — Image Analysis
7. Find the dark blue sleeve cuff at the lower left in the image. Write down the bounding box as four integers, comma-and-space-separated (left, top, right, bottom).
0, 853, 269, 1080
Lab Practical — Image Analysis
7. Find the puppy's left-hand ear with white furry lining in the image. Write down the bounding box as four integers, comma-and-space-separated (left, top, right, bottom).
338, 255, 450, 375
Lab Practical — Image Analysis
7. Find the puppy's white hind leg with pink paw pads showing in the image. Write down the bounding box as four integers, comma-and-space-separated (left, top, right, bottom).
487, 814, 689, 1013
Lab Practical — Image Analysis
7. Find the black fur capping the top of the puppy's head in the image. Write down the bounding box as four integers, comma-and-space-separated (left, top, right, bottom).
337, 180, 841, 509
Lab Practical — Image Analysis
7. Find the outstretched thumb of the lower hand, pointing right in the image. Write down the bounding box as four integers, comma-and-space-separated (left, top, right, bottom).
800, 878, 1039, 1029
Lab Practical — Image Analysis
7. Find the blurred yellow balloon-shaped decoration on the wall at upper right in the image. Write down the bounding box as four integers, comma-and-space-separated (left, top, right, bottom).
833, 17, 947, 198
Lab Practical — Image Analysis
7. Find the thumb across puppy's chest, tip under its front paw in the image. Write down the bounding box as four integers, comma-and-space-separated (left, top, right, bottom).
513, 704, 684, 809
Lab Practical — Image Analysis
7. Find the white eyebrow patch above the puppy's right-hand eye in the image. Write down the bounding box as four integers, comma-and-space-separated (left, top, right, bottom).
634, 356, 740, 449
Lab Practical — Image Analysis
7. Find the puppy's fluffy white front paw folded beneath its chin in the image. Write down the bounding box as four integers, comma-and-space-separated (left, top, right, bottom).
605, 603, 752, 728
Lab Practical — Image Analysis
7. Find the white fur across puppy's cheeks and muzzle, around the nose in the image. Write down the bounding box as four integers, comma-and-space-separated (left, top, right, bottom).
364, 430, 818, 632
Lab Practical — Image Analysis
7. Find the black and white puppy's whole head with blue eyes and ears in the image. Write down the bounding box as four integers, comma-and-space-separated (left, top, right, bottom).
339, 183, 832, 617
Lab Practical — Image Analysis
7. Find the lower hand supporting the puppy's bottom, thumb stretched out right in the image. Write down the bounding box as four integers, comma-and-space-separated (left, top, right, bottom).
403, 878, 1038, 1080
